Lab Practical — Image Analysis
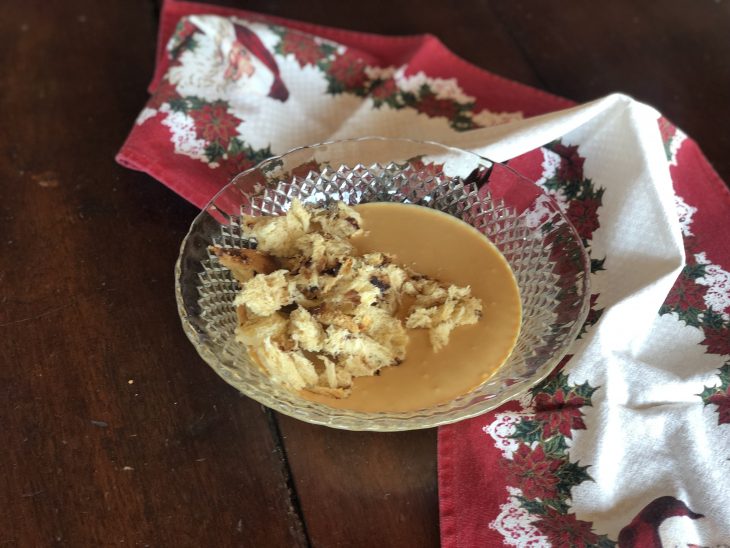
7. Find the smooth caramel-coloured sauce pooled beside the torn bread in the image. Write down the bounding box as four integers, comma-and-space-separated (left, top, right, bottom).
301, 203, 521, 412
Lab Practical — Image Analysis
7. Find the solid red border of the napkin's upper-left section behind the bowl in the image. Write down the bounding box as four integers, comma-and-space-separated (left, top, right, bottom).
117, 0, 573, 207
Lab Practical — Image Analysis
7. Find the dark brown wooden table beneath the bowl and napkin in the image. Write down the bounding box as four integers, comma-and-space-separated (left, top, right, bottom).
0, 0, 730, 547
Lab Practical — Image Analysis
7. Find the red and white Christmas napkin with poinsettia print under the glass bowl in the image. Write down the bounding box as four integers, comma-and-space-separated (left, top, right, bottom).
117, 1, 730, 546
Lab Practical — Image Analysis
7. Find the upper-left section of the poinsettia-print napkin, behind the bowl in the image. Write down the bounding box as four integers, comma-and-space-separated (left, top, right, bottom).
117, 3, 540, 206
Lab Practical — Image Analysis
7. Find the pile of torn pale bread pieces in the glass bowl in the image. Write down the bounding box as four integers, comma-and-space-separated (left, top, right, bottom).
211, 200, 482, 398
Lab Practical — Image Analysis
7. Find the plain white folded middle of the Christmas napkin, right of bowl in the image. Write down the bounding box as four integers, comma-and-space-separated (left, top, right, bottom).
456, 95, 730, 546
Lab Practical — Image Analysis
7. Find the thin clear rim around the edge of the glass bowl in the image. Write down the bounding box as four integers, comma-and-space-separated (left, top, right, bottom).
174, 136, 591, 432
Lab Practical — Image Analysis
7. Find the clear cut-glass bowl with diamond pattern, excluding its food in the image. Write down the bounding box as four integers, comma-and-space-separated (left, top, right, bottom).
175, 137, 590, 431
